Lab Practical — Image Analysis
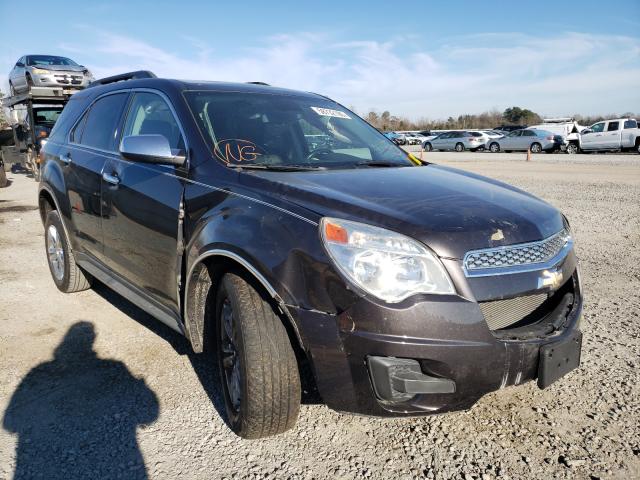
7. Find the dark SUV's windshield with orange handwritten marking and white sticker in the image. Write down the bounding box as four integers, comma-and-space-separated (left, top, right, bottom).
185, 91, 414, 168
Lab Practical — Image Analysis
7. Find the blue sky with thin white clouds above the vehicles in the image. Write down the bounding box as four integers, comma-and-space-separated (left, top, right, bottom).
0, 0, 640, 119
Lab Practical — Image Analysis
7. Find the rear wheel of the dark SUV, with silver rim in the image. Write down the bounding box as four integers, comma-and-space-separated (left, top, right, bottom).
44, 210, 91, 293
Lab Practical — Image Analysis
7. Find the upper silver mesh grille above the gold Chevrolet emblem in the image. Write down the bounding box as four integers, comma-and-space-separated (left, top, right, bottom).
463, 229, 571, 273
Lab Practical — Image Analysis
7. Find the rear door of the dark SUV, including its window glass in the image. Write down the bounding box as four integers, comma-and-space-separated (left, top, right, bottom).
63, 92, 129, 259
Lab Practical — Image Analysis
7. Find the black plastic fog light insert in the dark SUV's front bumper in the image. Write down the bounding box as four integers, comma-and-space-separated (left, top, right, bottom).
367, 357, 456, 402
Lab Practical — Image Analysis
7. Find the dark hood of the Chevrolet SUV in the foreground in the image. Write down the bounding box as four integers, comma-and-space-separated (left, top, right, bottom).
241, 165, 564, 258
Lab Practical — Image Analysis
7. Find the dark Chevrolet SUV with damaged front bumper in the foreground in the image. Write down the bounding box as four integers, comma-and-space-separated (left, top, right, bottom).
38, 72, 582, 438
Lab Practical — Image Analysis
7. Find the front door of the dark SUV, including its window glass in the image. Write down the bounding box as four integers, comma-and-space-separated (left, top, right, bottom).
102, 90, 186, 314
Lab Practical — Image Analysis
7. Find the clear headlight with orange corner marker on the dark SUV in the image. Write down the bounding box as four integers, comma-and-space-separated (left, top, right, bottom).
320, 217, 455, 303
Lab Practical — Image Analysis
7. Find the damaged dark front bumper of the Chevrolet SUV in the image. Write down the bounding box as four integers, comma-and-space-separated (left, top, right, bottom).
291, 253, 582, 416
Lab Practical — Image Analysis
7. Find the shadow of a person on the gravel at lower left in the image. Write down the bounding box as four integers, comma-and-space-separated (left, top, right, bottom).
2, 322, 158, 480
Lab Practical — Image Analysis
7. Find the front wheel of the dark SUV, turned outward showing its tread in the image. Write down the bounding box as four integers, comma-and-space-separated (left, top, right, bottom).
215, 273, 301, 438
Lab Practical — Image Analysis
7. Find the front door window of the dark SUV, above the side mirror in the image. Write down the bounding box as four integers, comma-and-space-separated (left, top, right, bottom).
122, 92, 185, 150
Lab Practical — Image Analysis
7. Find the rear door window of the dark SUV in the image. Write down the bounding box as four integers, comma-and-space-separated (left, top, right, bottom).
79, 93, 128, 152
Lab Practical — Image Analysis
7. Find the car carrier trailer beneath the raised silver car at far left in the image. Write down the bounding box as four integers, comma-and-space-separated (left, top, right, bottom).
0, 87, 78, 180
